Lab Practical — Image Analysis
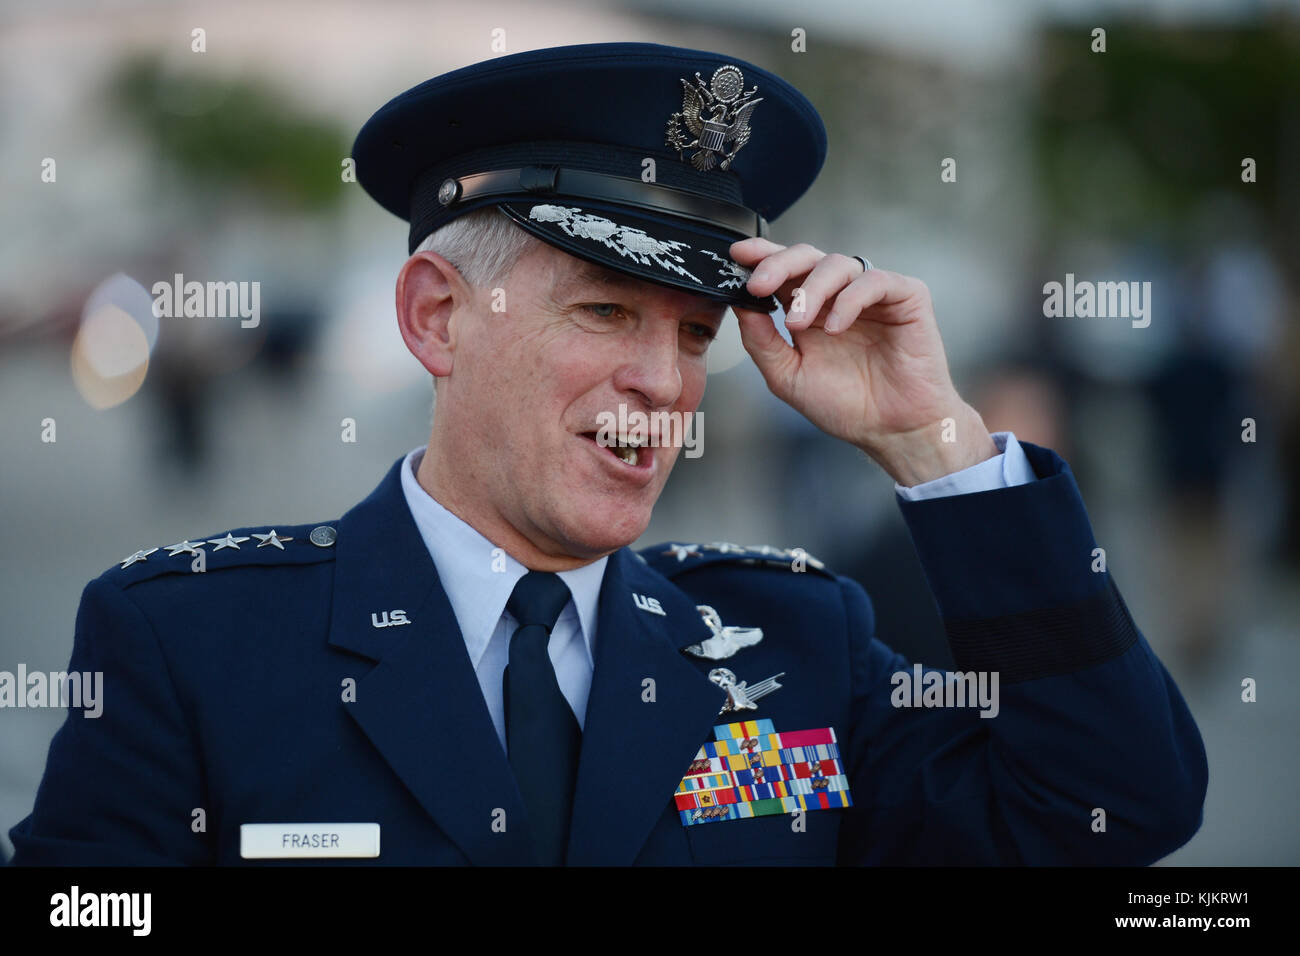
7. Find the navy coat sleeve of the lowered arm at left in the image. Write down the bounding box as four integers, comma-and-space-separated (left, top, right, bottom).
9, 578, 211, 866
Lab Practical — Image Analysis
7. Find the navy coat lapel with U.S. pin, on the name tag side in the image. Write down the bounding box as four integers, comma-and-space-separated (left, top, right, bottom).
329, 459, 535, 864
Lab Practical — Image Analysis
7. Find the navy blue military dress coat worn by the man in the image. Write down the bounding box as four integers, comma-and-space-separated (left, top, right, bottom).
10, 444, 1206, 866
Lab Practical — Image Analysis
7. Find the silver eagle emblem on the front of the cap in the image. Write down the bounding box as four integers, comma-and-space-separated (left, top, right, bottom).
664, 65, 763, 172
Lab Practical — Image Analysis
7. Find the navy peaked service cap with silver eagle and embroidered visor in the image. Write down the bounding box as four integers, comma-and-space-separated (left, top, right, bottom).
352, 43, 827, 312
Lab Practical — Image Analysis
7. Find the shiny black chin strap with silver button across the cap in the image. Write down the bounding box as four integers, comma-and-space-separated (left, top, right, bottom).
412, 166, 767, 238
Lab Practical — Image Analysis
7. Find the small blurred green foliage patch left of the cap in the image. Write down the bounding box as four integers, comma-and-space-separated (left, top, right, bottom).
108, 56, 348, 212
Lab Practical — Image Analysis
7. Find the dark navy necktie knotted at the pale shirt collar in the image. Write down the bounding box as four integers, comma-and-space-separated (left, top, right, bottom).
502, 571, 582, 866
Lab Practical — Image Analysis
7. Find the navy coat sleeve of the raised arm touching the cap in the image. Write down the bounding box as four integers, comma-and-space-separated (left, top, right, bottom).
840, 442, 1208, 865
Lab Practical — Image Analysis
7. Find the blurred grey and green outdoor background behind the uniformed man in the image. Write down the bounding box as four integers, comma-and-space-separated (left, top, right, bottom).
0, 0, 1300, 865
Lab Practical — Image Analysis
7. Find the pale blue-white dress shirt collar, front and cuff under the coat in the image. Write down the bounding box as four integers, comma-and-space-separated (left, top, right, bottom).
402, 432, 1036, 750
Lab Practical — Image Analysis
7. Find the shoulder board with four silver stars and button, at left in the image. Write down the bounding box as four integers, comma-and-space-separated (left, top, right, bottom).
104, 522, 338, 588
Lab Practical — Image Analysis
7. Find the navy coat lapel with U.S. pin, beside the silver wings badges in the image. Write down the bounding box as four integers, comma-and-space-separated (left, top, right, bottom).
568, 548, 727, 866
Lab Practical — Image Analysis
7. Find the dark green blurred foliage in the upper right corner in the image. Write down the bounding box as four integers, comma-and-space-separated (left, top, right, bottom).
1034, 21, 1300, 257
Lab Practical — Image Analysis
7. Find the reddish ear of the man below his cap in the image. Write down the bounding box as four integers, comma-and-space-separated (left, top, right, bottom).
397, 252, 472, 377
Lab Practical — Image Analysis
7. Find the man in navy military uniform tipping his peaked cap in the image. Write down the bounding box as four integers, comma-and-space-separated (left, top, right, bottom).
10, 44, 1206, 865
